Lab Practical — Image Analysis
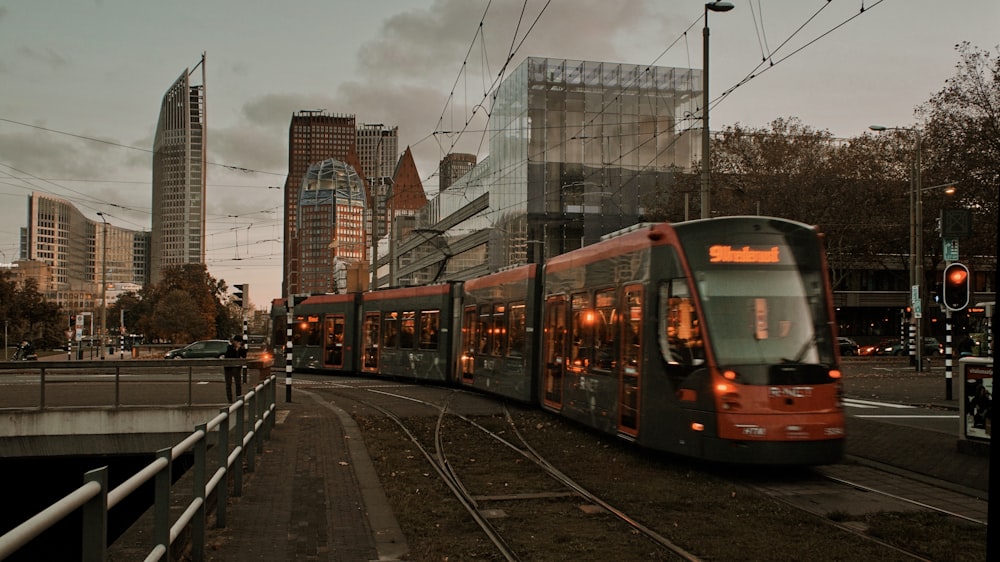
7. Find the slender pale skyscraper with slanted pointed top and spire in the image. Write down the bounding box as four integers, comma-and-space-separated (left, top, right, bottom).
149, 54, 206, 283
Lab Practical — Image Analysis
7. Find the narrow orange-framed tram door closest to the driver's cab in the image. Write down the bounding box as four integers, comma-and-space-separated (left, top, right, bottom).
618, 285, 642, 437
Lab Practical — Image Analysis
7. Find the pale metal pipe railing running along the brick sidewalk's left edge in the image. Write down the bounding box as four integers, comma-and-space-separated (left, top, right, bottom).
0, 375, 276, 561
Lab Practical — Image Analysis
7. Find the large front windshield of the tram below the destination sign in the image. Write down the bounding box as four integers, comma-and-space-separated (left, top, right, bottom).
696, 266, 834, 365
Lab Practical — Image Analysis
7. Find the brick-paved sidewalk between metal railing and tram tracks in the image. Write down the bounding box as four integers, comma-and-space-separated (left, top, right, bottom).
205, 389, 407, 562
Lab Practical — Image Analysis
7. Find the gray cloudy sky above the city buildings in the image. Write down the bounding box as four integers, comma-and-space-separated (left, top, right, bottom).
0, 0, 1000, 306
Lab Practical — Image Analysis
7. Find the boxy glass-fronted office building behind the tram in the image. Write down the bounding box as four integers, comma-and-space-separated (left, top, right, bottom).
397, 58, 701, 282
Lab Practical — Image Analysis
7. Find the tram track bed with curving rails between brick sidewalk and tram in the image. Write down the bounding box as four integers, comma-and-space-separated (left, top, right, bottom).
297, 378, 985, 560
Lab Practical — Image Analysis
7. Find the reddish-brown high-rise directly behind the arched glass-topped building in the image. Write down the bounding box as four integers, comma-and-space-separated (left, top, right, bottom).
282, 109, 360, 295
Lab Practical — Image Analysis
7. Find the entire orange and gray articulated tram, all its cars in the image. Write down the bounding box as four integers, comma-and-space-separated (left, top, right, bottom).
293, 217, 844, 465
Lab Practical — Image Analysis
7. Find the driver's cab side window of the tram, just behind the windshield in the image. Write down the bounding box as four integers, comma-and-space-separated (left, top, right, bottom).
660, 278, 705, 369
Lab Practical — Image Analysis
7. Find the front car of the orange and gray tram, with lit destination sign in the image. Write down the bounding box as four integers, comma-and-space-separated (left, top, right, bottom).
539, 217, 844, 464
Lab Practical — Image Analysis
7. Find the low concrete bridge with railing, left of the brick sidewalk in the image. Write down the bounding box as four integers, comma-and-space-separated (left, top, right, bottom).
0, 359, 270, 458
